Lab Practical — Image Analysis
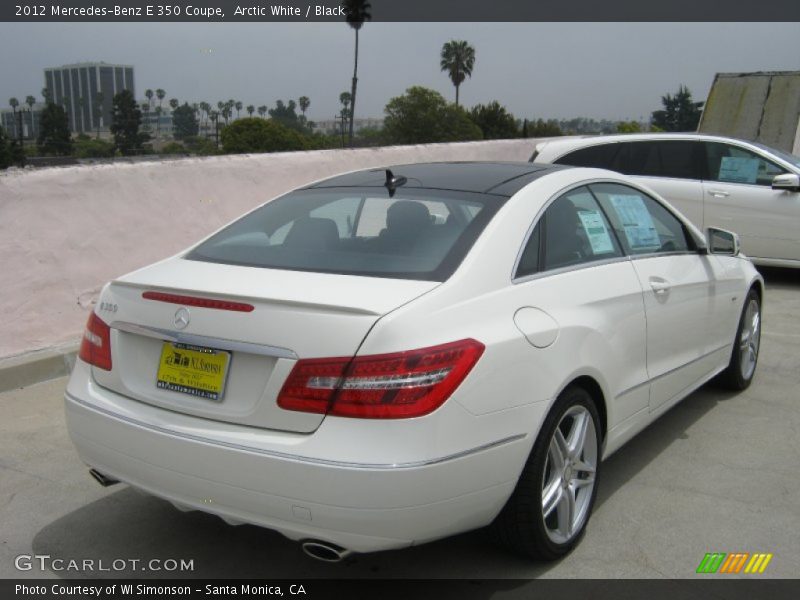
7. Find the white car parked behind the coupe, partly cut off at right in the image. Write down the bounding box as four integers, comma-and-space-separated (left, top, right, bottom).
531, 133, 800, 267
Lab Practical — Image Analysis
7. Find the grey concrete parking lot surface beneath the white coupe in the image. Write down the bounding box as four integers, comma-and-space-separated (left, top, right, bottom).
0, 270, 800, 578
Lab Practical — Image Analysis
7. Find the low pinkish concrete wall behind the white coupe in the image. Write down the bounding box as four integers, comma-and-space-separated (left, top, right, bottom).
0, 139, 537, 359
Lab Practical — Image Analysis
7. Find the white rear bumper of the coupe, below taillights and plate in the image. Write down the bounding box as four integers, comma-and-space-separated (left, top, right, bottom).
65, 366, 530, 552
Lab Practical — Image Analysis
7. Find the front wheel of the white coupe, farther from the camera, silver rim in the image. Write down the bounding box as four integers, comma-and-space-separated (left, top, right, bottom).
717, 289, 761, 391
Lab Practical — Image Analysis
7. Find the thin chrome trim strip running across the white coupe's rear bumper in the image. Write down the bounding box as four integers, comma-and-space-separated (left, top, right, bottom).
64, 392, 526, 470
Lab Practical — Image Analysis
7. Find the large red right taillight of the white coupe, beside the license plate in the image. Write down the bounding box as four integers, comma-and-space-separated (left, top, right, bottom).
278, 339, 484, 419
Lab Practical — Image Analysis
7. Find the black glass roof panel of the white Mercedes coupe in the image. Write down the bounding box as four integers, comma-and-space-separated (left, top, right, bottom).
305, 161, 572, 196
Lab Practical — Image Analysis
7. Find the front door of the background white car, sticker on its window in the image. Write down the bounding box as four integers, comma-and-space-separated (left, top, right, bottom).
703, 142, 800, 260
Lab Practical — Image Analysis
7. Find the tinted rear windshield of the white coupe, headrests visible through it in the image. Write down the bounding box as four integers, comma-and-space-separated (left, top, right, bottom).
185, 188, 506, 281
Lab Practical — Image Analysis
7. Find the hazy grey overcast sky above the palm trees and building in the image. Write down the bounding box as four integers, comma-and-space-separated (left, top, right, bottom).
0, 23, 800, 120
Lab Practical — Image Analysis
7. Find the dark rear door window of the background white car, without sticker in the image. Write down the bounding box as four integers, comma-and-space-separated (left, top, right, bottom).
611, 140, 700, 179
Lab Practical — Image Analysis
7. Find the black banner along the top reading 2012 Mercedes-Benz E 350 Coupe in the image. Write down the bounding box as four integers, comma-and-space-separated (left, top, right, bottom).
0, 0, 800, 23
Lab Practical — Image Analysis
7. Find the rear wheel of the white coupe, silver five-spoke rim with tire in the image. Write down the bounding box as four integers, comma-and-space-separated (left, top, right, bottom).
490, 386, 601, 560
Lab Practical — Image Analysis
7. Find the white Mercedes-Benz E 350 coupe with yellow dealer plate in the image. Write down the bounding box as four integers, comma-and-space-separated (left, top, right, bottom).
66, 162, 764, 561
